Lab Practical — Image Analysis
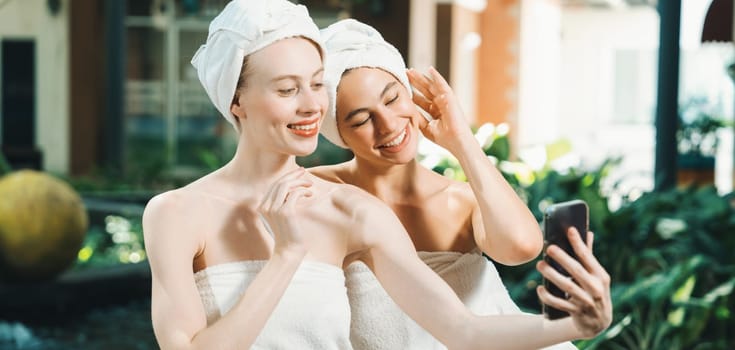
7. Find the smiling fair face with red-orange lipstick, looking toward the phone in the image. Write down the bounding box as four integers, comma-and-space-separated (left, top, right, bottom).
230, 38, 327, 156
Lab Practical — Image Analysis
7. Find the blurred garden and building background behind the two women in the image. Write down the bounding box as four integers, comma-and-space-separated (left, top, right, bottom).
0, 0, 735, 349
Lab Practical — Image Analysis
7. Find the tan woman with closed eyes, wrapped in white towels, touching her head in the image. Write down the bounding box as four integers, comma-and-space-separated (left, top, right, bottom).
310, 20, 609, 349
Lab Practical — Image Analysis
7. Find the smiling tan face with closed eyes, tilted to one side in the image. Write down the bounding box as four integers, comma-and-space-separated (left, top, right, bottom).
336, 67, 421, 164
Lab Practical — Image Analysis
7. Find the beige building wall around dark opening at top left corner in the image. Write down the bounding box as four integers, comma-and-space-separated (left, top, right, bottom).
0, 0, 70, 173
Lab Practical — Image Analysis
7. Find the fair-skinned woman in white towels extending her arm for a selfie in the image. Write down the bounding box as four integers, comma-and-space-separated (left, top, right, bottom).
143, 4, 611, 349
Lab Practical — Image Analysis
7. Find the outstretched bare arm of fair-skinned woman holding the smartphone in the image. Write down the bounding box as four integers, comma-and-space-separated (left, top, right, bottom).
358, 196, 612, 349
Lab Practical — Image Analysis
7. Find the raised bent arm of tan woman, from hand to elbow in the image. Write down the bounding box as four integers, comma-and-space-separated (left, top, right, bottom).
408, 68, 543, 265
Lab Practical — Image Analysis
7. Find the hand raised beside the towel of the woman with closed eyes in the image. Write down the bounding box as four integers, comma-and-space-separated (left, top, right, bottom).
407, 67, 474, 153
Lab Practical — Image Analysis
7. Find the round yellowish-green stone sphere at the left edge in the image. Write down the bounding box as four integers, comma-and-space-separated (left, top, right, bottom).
0, 170, 89, 282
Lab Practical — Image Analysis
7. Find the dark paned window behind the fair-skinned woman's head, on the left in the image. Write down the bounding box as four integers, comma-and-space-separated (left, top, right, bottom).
125, 0, 230, 175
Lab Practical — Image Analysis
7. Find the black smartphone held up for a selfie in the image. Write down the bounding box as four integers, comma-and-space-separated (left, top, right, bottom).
542, 199, 589, 320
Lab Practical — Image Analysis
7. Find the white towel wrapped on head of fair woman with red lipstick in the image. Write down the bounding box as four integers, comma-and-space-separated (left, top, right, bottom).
191, 0, 325, 131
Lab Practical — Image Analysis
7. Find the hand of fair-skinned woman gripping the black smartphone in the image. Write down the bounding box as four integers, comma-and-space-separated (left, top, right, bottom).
536, 227, 612, 338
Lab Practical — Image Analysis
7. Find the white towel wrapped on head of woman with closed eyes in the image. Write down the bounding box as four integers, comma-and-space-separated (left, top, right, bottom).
321, 19, 411, 148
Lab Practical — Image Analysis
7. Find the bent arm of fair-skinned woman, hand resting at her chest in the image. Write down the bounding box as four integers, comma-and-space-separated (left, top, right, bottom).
143, 168, 314, 349
